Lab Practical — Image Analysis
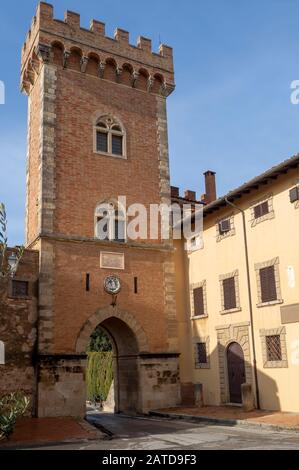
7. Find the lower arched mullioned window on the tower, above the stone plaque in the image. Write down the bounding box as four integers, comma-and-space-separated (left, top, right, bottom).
95, 202, 126, 243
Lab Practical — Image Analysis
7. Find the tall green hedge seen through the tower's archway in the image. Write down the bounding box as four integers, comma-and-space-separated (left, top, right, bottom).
86, 352, 113, 402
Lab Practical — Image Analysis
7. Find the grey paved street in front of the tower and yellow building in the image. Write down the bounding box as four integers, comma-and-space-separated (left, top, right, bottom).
24, 412, 299, 450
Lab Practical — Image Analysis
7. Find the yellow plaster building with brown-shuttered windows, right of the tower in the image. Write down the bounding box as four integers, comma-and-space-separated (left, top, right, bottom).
175, 155, 299, 412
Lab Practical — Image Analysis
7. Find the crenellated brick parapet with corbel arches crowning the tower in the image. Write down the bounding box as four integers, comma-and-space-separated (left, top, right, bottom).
21, 2, 175, 96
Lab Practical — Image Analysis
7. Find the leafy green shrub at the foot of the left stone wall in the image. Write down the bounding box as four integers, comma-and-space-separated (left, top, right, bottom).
0, 392, 30, 440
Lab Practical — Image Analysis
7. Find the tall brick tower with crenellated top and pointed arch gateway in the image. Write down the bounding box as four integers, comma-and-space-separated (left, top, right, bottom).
21, 3, 179, 416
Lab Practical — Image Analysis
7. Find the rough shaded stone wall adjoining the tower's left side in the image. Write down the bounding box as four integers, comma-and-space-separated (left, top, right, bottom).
0, 250, 39, 412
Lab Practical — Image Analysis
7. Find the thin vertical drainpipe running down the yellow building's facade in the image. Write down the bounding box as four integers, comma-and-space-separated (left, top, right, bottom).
225, 198, 260, 410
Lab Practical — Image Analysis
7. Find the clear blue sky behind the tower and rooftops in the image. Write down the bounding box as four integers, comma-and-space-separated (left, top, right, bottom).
0, 0, 299, 244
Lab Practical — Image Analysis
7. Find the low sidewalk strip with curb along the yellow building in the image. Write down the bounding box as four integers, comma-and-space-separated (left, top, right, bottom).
149, 411, 299, 433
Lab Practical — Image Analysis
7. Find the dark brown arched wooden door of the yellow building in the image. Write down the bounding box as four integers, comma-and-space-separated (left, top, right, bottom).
227, 343, 246, 403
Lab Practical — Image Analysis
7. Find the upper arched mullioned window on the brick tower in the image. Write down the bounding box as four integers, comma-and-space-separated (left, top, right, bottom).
94, 116, 127, 158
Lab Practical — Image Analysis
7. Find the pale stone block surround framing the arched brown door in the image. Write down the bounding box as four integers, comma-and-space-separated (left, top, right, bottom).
215, 322, 253, 404
